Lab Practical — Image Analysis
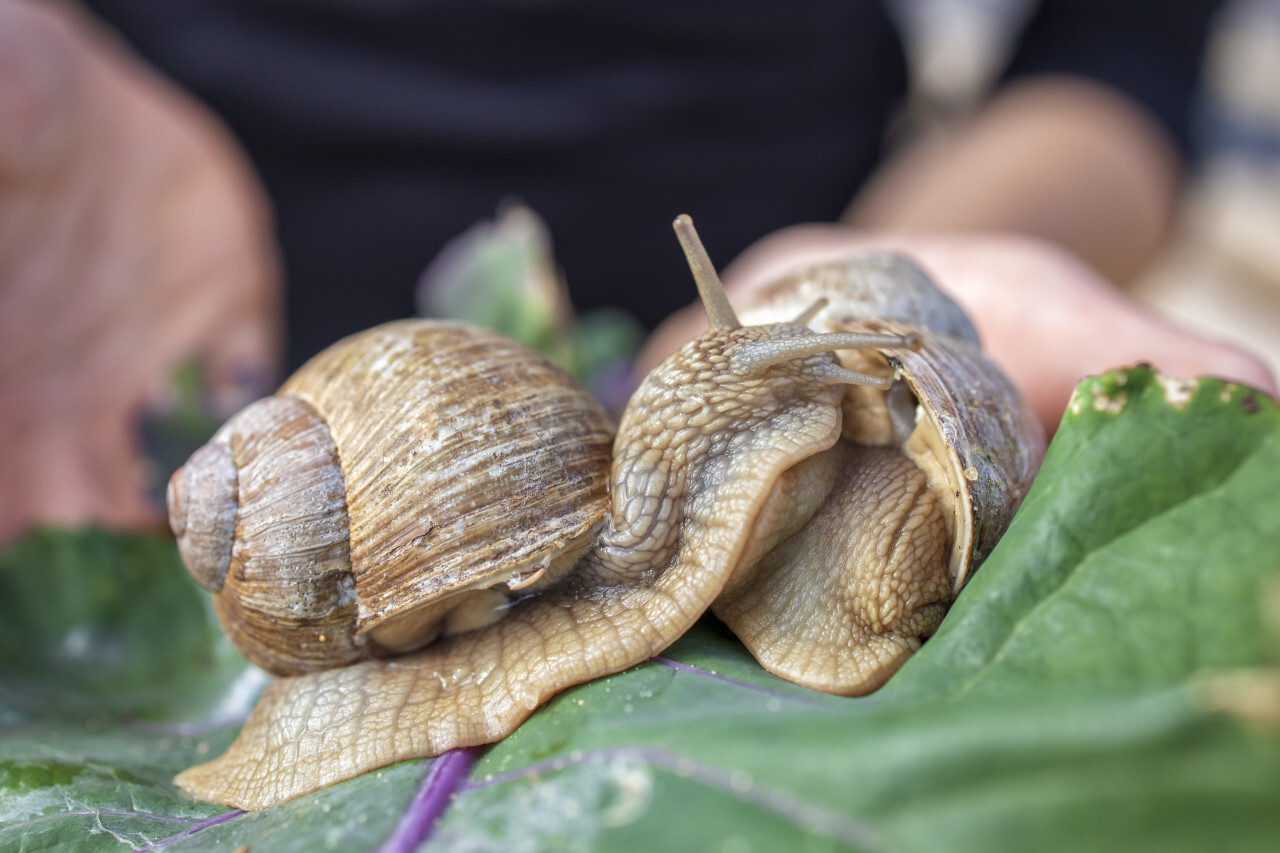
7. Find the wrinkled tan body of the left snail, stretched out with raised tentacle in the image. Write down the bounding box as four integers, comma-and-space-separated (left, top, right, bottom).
177, 220, 931, 808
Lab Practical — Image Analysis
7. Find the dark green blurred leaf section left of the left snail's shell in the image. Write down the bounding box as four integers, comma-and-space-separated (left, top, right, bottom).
0, 530, 261, 721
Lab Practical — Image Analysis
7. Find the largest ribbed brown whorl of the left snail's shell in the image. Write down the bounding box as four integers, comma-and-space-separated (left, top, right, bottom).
282, 320, 613, 642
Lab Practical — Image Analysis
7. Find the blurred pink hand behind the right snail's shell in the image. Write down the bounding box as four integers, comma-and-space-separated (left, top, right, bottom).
639, 225, 1276, 432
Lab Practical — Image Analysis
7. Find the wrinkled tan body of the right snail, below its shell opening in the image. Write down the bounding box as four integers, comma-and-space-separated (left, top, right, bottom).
713, 442, 952, 695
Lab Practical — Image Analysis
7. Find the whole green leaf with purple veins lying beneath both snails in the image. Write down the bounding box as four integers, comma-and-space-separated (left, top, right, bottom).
0, 369, 1280, 852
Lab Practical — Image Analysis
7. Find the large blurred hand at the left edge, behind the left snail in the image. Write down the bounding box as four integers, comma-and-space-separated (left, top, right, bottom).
0, 0, 279, 542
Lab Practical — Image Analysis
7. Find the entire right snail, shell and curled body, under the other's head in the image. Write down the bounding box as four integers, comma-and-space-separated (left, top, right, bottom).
713, 255, 1044, 695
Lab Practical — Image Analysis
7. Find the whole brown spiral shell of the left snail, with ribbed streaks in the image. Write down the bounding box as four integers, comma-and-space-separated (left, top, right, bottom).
170, 320, 613, 674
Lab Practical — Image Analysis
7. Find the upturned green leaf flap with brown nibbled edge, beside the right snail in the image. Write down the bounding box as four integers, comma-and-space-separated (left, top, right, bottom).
886, 368, 1280, 699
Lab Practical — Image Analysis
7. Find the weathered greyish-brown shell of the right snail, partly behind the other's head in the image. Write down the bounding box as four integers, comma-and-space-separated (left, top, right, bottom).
741, 254, 1044, 590
